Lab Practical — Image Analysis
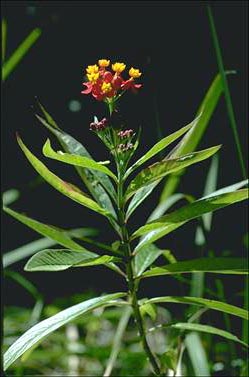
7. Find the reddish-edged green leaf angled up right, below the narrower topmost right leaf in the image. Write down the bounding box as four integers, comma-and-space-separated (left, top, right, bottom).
126, 145, 221, 200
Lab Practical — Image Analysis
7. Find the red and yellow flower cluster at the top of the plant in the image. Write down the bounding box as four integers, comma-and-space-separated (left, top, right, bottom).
81, 59, 142, 101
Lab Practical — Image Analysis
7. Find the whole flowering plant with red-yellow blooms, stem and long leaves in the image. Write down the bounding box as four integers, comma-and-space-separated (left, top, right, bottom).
4, 59, 248, 376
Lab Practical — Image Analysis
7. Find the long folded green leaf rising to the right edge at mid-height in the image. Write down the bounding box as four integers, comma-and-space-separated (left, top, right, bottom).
132, 189, 248, 253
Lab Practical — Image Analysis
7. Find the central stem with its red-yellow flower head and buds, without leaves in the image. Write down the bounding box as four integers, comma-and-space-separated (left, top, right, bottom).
81, 59, 162, 376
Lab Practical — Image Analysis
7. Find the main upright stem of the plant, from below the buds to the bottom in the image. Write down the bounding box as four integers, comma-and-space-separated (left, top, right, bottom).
118, 166, 161, 376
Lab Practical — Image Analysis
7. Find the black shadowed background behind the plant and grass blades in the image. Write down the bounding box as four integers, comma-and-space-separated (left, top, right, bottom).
2, 1, 248, 305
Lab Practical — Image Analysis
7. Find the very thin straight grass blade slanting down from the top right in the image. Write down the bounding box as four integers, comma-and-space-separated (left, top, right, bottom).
207, 5, 246, 179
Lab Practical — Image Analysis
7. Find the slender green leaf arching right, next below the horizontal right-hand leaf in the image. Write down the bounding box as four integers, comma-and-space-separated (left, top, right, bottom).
143, 296, 248, 320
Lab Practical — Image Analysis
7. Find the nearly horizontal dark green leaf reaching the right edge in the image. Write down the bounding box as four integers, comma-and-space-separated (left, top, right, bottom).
141, 258, 248, 278
